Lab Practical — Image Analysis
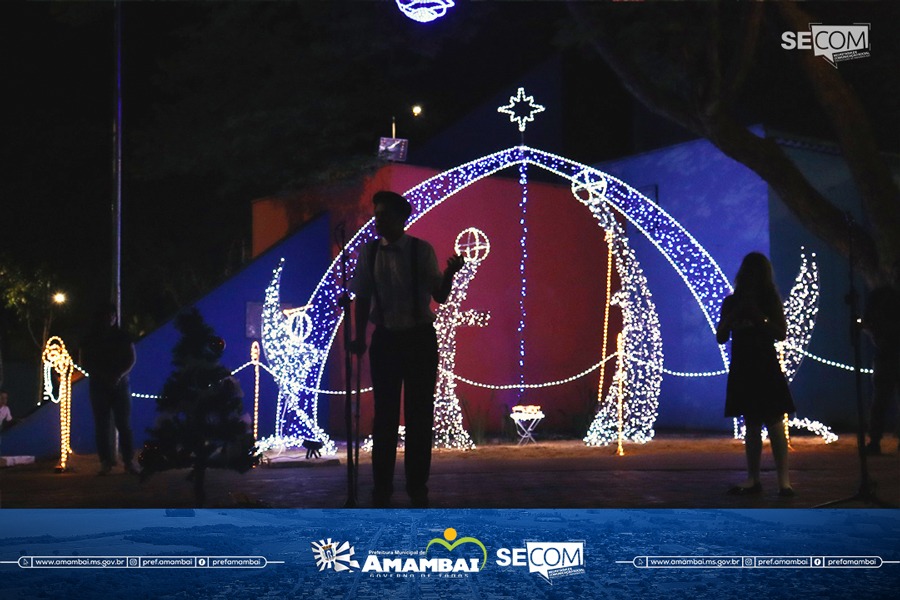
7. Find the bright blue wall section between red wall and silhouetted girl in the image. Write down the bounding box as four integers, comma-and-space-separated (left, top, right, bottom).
597, 134, 768, 430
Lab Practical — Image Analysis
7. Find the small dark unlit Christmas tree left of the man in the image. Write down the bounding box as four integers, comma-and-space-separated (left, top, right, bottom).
138, 309, 257, 506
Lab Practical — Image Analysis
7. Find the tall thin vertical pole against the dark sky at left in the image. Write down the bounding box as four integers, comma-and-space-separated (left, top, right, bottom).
111, 0, 122, 326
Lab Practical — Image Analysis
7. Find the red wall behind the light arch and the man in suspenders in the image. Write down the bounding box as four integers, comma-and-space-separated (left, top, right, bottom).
254, 165, 621, 437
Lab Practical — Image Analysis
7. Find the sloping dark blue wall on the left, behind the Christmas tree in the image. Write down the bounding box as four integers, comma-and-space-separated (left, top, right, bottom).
3, 215, 331, 456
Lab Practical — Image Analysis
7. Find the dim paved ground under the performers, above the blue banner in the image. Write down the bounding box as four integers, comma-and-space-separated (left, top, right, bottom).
0, 435, 900, 508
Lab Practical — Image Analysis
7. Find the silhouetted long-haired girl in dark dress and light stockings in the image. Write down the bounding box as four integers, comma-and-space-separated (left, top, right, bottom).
716, 252, 796, 496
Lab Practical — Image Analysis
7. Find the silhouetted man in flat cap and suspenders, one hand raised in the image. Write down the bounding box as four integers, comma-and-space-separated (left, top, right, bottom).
350, 191, 463, 508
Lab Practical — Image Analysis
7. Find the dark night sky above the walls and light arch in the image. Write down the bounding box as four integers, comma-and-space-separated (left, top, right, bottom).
0, 0, 900, 350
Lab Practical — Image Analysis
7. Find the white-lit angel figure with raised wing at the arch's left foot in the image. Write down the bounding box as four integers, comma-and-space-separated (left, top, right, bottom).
258, 260, 337, 455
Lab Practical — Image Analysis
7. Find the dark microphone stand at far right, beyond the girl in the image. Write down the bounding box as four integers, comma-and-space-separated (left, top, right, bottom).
815, 212, 897, 508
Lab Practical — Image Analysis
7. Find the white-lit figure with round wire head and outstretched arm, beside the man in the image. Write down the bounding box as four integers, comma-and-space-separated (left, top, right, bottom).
434, 227, 491, 450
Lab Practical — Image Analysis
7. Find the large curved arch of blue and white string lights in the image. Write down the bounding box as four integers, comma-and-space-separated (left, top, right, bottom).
264, 145, 768, 452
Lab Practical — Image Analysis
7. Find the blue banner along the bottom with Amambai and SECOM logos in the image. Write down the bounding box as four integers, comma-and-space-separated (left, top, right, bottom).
0, 509, 900, 600
